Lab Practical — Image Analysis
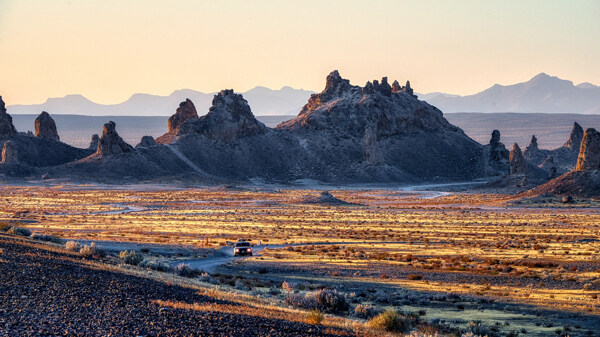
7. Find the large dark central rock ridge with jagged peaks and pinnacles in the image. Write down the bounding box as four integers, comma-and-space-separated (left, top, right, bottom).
1, 71, 488, 183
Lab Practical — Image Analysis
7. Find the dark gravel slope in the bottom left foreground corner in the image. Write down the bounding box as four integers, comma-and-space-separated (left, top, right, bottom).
0, 236, 346, 336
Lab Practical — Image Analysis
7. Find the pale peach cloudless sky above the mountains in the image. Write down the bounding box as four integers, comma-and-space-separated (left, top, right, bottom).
0, 0, 600, 105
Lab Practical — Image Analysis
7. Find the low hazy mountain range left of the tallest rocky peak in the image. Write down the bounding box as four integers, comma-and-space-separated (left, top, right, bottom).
5, 87, 314, 116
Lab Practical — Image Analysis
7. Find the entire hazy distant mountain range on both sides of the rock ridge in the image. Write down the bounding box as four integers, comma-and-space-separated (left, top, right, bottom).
8, 73, 600, 116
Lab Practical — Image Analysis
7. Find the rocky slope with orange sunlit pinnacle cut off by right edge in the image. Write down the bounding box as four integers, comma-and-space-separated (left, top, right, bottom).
525, 128, 600, 198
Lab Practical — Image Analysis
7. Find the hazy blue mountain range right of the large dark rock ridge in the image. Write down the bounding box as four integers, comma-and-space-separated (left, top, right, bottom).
419, 73, 600, 114
